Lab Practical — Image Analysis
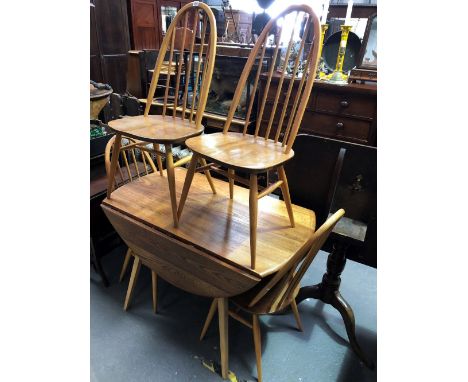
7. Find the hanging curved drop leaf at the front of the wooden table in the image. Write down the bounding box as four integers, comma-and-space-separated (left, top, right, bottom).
103, 206, 260, 297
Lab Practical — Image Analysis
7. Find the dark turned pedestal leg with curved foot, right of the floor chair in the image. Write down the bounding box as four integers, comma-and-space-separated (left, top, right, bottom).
296, 243, 374, 369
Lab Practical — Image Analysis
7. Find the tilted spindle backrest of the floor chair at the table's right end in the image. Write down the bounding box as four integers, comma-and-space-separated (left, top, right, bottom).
249, 209, 345, 311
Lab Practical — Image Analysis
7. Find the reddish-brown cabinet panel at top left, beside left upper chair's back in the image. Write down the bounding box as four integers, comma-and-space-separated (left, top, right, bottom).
131, 0, 160, 49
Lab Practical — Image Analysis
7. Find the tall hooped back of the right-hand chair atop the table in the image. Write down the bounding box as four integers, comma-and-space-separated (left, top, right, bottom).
223, 5, 321, 153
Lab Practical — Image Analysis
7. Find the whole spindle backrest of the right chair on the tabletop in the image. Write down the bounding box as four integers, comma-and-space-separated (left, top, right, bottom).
223, 5, 321, 153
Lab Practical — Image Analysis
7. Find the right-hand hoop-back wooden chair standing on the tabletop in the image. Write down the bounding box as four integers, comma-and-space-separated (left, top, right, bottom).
178, 5, 320, 268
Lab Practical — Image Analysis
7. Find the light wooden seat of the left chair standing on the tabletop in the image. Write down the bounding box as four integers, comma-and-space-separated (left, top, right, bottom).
109, 115, 204, 143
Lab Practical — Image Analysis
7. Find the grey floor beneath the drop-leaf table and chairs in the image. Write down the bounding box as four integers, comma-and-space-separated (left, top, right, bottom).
91, 248, 377, 382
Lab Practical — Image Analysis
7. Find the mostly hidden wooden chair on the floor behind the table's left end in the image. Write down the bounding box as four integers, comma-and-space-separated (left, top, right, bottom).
104, 136, 158, 313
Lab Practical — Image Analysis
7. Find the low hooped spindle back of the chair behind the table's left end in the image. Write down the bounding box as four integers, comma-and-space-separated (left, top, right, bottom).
104, 135, 157, 188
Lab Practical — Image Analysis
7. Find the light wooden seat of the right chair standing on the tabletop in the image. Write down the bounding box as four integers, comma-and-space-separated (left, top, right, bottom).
185, 132, 294, 173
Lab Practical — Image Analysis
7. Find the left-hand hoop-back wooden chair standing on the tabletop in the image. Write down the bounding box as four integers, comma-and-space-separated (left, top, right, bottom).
107, 1, 216, 227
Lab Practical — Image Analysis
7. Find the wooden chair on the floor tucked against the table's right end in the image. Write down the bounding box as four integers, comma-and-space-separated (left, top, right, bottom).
200, 209, 345, 382
